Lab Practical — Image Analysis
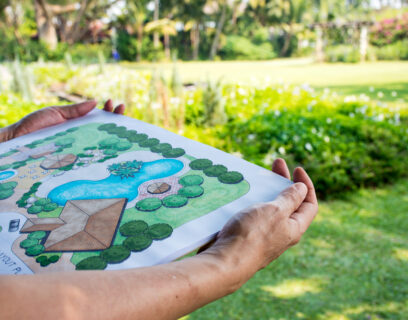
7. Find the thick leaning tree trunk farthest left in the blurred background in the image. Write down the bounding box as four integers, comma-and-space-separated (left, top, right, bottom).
35, 0, 58, 50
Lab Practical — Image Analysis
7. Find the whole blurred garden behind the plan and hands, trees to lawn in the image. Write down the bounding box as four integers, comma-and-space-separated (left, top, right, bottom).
0, 0, 408, 320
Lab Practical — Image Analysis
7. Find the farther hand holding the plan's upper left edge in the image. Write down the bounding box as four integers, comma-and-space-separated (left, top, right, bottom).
0, 99, 125, 142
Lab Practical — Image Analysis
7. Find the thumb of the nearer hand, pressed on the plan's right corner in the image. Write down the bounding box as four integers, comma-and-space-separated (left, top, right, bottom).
272, 182, 307, 217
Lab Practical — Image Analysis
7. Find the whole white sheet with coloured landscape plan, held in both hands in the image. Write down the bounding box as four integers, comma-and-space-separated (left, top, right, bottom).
0, 110, 290, 274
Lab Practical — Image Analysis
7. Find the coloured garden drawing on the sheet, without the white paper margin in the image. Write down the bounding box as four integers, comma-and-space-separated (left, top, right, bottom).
0, 122, 250, 273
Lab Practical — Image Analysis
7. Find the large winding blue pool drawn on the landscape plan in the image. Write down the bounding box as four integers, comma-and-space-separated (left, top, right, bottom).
48, 159, 184, 206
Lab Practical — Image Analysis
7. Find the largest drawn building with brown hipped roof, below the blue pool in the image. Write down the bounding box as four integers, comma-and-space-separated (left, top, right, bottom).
21, 198, 127, 251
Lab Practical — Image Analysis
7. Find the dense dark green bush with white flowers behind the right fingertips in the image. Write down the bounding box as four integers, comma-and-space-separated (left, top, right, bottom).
225, 104, 408, 197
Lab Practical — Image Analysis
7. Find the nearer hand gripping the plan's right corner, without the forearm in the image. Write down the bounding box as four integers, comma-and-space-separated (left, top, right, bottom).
204, 159, 318, 286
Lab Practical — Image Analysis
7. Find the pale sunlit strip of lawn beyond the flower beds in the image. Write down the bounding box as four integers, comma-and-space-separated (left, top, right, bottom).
123, 58, 408, 101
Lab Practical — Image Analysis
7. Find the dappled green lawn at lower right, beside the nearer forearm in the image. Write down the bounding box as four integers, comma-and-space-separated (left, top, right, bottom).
186, 181, 408, 320
